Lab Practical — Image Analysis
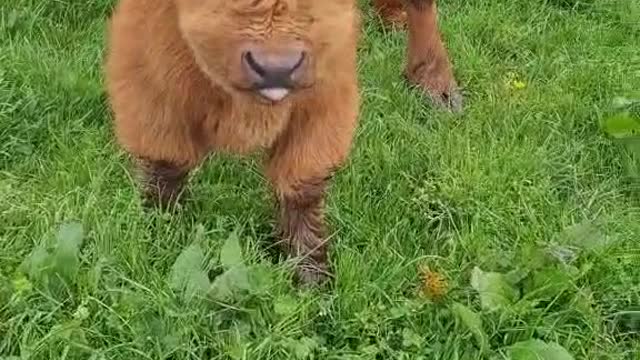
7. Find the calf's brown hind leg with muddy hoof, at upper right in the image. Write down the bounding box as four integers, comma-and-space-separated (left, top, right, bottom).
374, 0, 462, 111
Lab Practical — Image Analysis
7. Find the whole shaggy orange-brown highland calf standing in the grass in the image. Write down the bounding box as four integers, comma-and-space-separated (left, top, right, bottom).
106, 0, 458, 283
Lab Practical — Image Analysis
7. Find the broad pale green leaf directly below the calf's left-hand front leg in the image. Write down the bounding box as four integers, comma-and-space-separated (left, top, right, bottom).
169, 244, 209, 299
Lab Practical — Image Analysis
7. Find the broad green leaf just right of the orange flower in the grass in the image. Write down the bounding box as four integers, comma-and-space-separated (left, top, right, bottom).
471, 266, 518, 311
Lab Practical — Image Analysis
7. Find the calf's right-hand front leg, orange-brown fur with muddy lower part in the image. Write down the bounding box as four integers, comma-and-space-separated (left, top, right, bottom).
267, 84, 359, 285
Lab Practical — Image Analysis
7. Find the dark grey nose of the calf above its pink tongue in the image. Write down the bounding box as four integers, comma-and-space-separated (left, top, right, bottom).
242, 50, 306, 89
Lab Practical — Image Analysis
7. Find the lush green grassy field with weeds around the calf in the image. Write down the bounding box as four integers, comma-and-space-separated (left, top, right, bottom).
0, 0, 640, 360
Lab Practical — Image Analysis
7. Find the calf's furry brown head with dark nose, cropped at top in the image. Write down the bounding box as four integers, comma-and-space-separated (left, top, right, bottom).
174, 0, 357, 103
